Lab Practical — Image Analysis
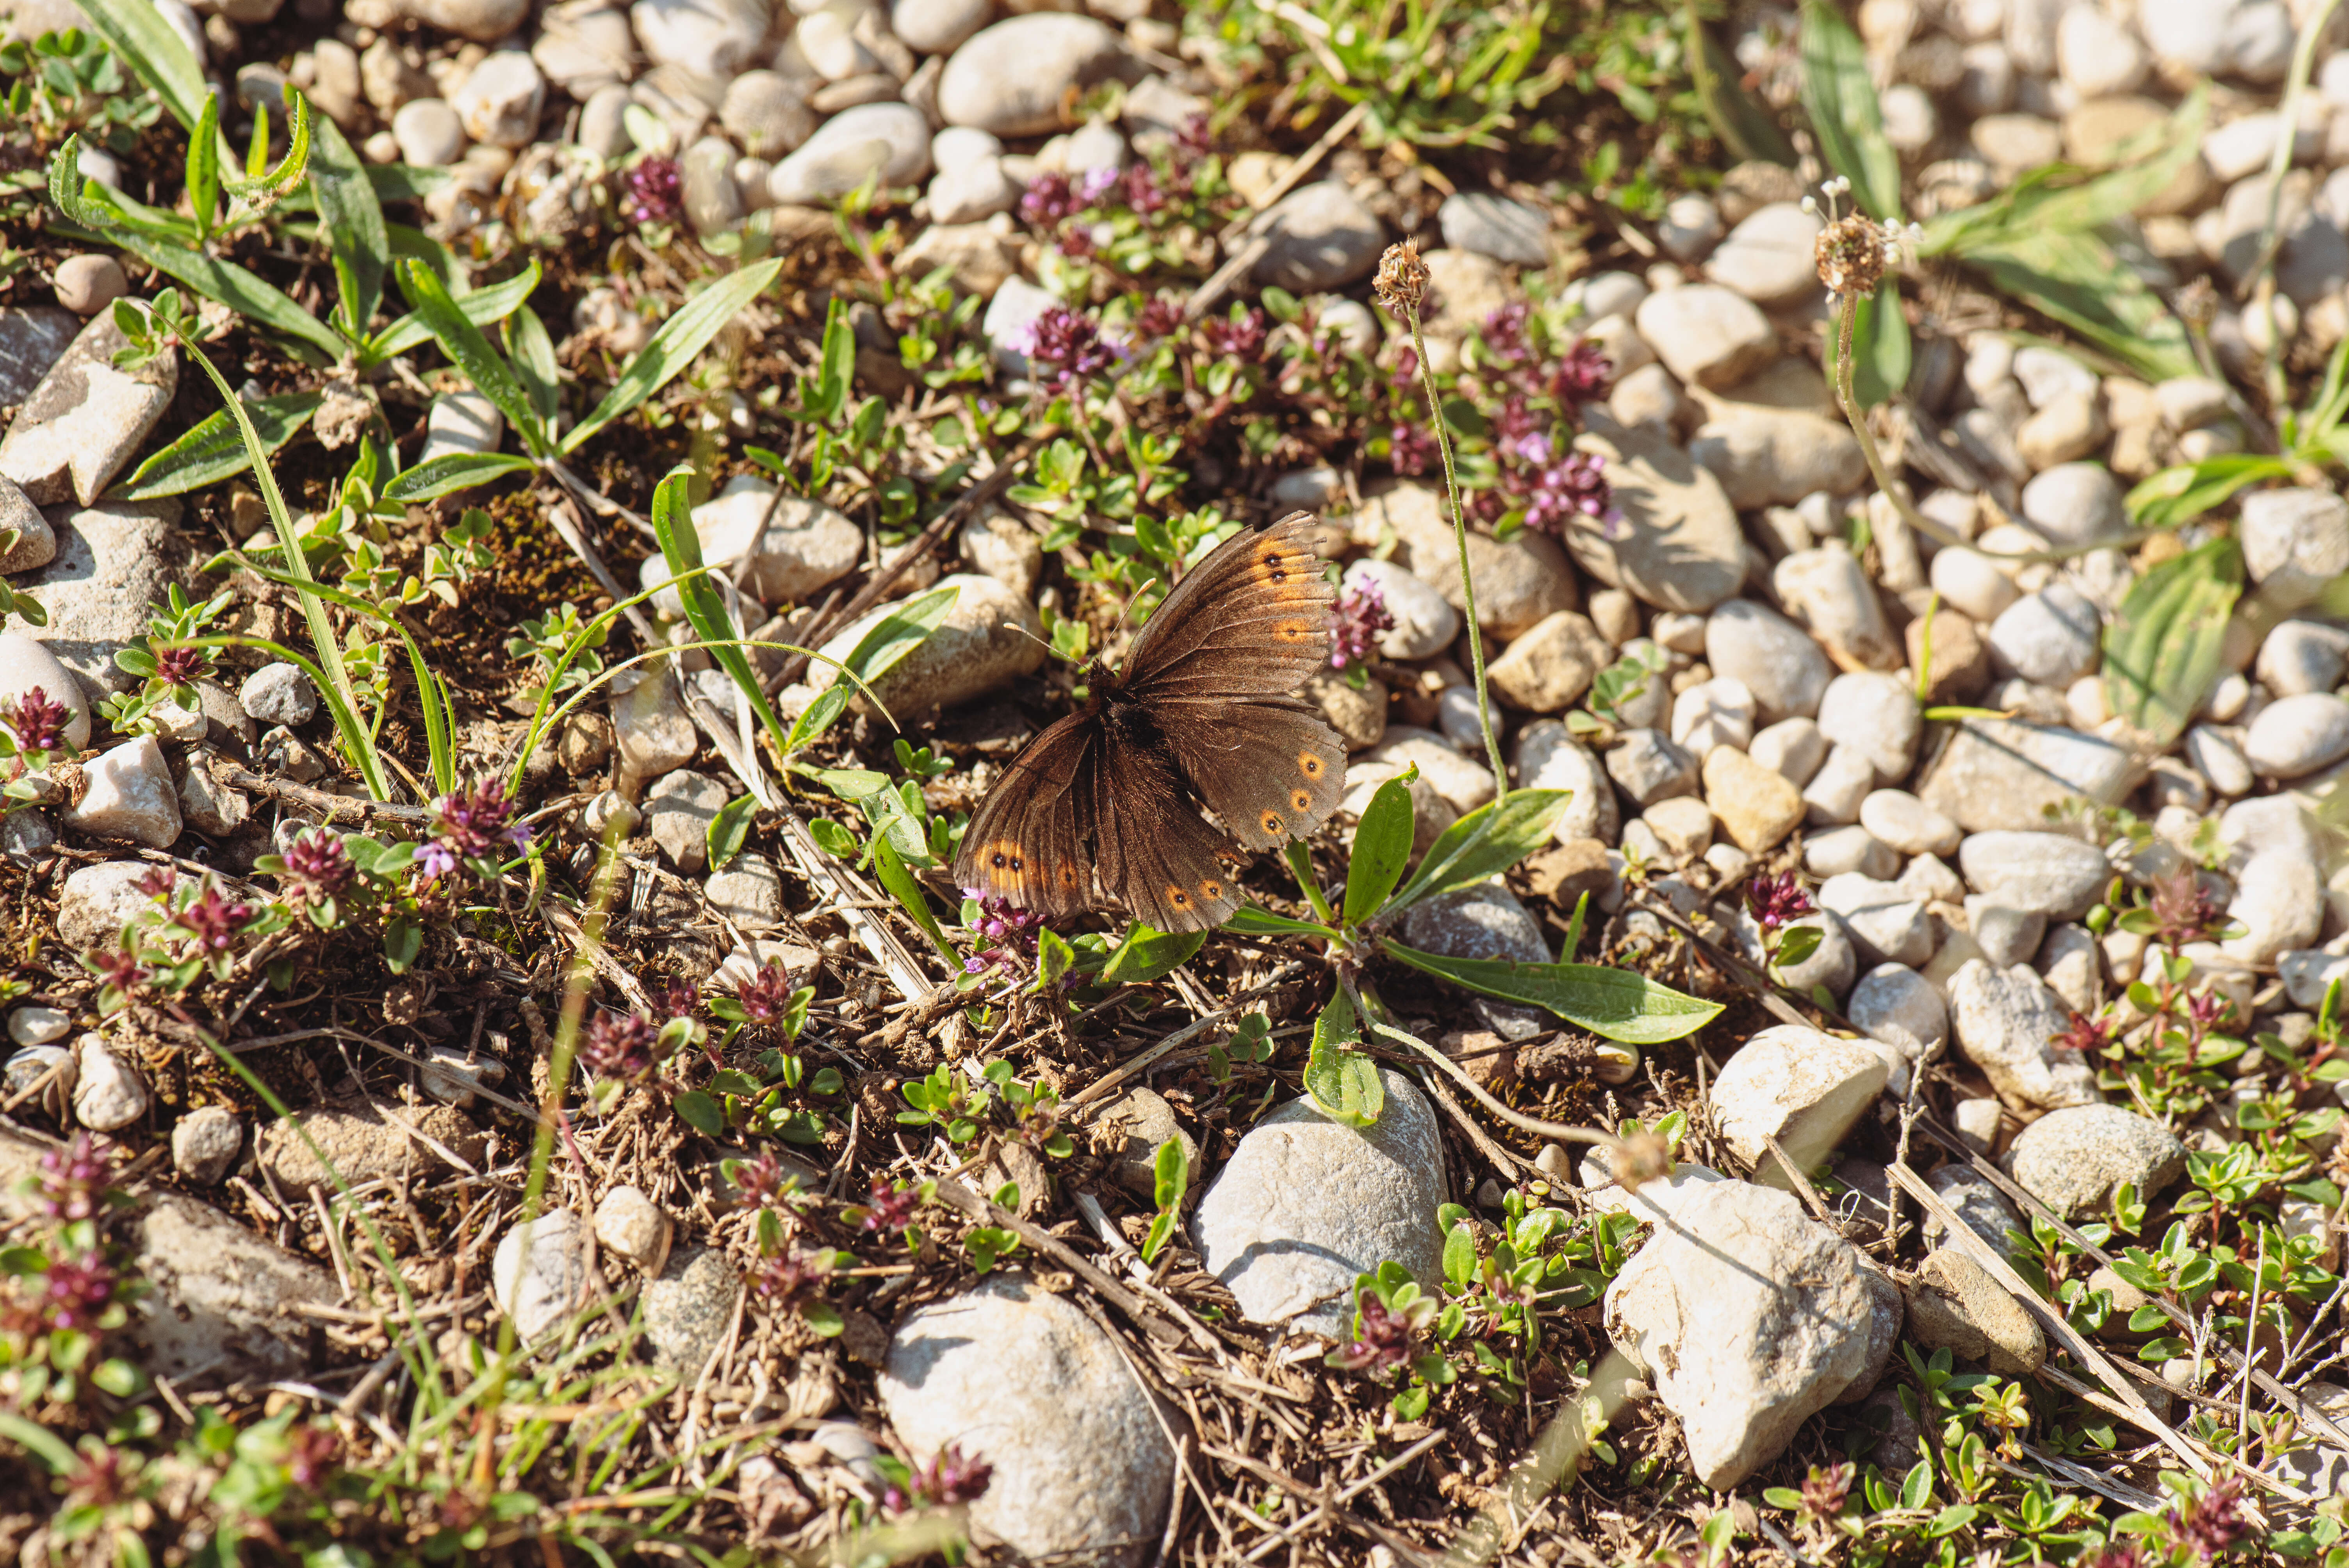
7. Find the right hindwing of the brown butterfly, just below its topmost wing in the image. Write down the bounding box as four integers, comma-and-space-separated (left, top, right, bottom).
1153, 697, 1346, 850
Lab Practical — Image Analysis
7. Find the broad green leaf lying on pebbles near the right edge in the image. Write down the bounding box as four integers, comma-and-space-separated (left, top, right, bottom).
2105, 540, 2243, 747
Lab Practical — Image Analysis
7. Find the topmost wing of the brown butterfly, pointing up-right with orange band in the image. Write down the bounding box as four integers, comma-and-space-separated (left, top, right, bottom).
1123, 512, 1337, 702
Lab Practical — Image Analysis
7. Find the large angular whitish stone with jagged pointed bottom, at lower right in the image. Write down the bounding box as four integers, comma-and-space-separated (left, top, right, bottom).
1604, 1181, 1889, 1488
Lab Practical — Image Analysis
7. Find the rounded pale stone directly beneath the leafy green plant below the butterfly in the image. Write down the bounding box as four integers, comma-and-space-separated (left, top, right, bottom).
1193, 1068, 1445, 1338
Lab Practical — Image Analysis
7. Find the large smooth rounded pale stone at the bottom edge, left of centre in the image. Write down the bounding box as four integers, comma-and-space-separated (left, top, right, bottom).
881, 1277, 1174, 1568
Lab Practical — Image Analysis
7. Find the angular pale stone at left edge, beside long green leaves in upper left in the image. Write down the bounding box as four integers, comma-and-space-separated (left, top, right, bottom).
0, 312, 178, 511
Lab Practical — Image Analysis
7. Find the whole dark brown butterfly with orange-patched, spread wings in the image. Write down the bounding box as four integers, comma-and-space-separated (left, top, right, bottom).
954, 512, 1346, 932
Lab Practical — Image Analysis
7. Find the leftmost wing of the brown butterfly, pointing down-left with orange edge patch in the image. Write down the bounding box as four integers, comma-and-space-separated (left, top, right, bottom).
954, 711, 1102, 920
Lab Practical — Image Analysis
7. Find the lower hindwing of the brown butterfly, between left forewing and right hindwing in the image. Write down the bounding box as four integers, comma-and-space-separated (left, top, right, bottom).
1094, 732, 1240, 932
